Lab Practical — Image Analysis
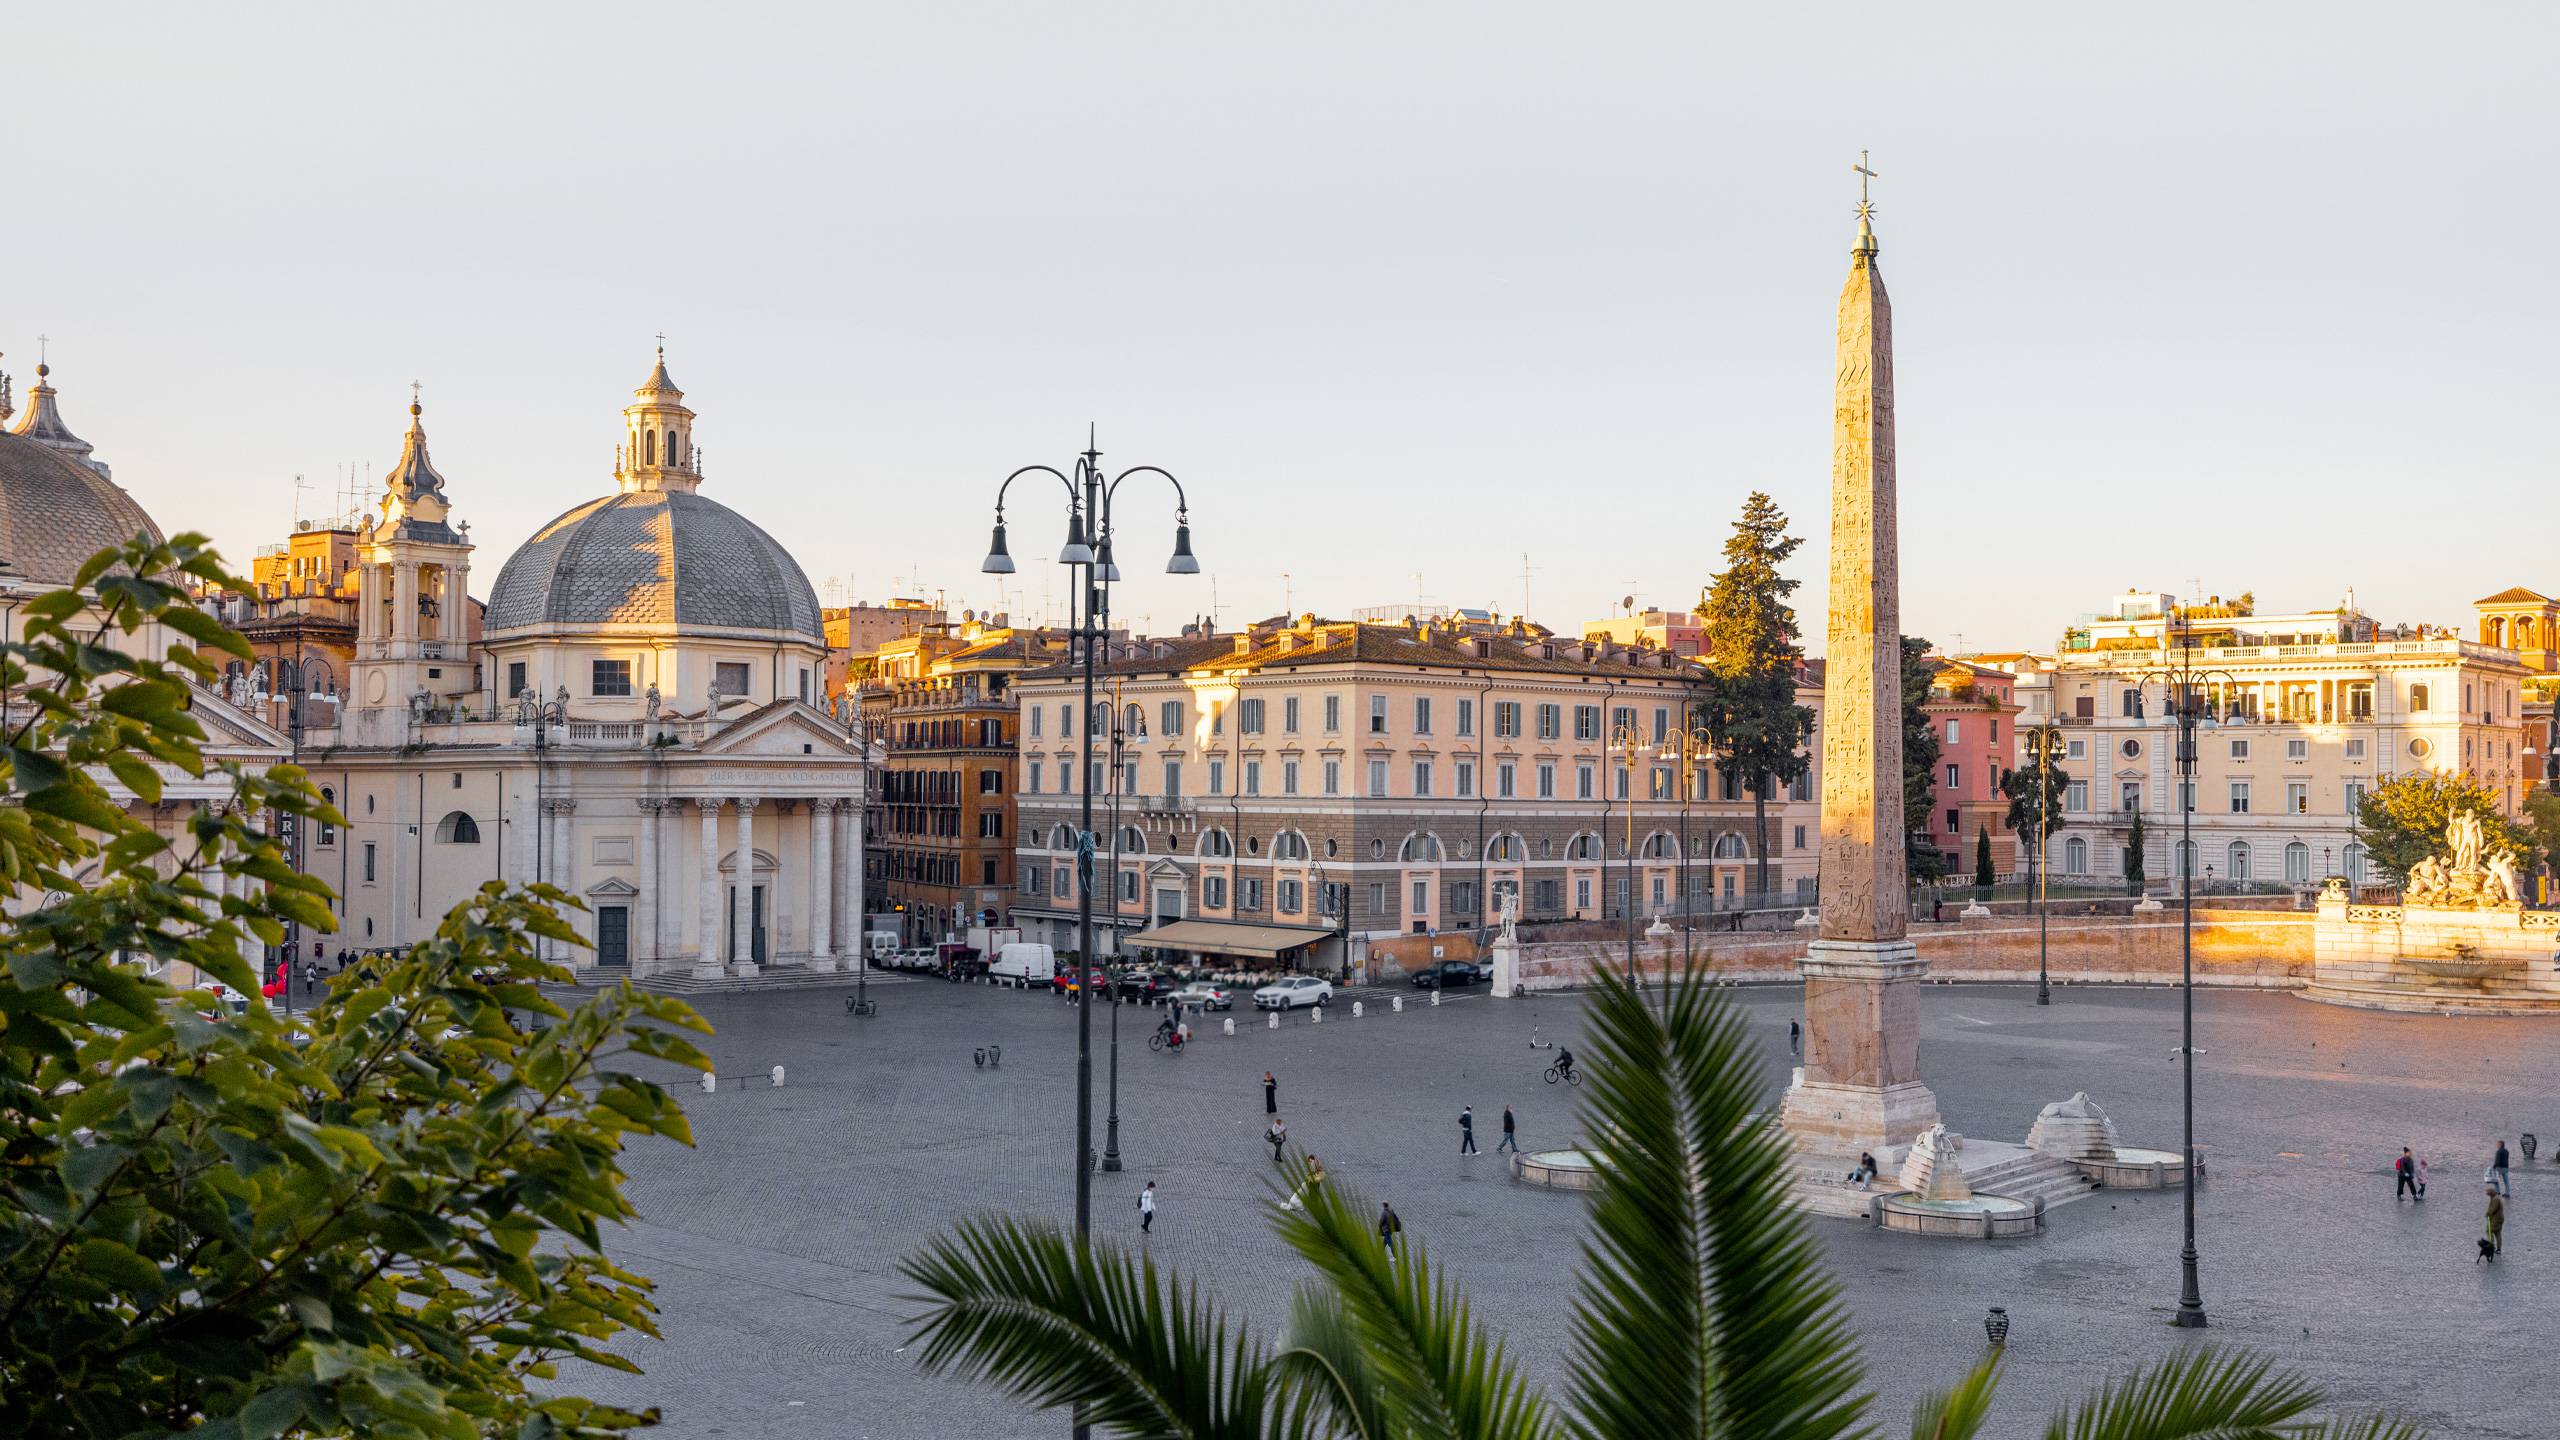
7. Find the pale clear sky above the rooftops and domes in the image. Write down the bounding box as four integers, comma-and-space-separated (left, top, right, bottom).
0, 0, 2560, 648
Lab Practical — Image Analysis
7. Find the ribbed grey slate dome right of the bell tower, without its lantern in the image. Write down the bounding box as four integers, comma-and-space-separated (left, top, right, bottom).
481, 489, 827, 635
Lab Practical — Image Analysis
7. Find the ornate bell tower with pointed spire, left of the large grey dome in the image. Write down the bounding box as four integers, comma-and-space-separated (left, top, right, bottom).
353, 387, 476, 715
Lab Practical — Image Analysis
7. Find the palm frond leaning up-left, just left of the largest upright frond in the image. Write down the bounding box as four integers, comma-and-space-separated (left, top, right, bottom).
1272, 1153, 1556, 1440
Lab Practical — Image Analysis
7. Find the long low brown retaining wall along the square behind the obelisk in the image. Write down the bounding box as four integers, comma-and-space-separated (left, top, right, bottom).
1521, 910, 2312, 989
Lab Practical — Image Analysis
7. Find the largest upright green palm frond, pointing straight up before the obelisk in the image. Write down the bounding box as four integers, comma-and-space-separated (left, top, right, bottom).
1572, 971, 1866, 1440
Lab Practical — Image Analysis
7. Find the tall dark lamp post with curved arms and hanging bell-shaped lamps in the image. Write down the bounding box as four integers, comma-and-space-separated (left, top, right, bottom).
978, 436, 1201, 1435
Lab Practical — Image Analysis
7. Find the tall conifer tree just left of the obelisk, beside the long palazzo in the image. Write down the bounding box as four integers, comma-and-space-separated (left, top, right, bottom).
1697, 489, 1812, 897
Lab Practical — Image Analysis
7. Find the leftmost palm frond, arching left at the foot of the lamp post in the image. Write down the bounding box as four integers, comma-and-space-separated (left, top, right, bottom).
899, 1217, 1270, 1440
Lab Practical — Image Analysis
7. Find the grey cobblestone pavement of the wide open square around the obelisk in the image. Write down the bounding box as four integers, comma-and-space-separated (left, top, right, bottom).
571, 981, 2560, 1440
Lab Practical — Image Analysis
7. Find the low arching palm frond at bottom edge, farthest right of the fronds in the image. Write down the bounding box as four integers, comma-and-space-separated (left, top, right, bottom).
2045, 1348, 2419, 1440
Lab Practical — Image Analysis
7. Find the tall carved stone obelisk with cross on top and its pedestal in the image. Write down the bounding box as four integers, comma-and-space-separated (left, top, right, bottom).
1779, 164, 1938, 1168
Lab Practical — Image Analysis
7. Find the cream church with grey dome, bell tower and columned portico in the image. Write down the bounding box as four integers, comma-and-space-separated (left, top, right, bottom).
305, 354, 865, 979
